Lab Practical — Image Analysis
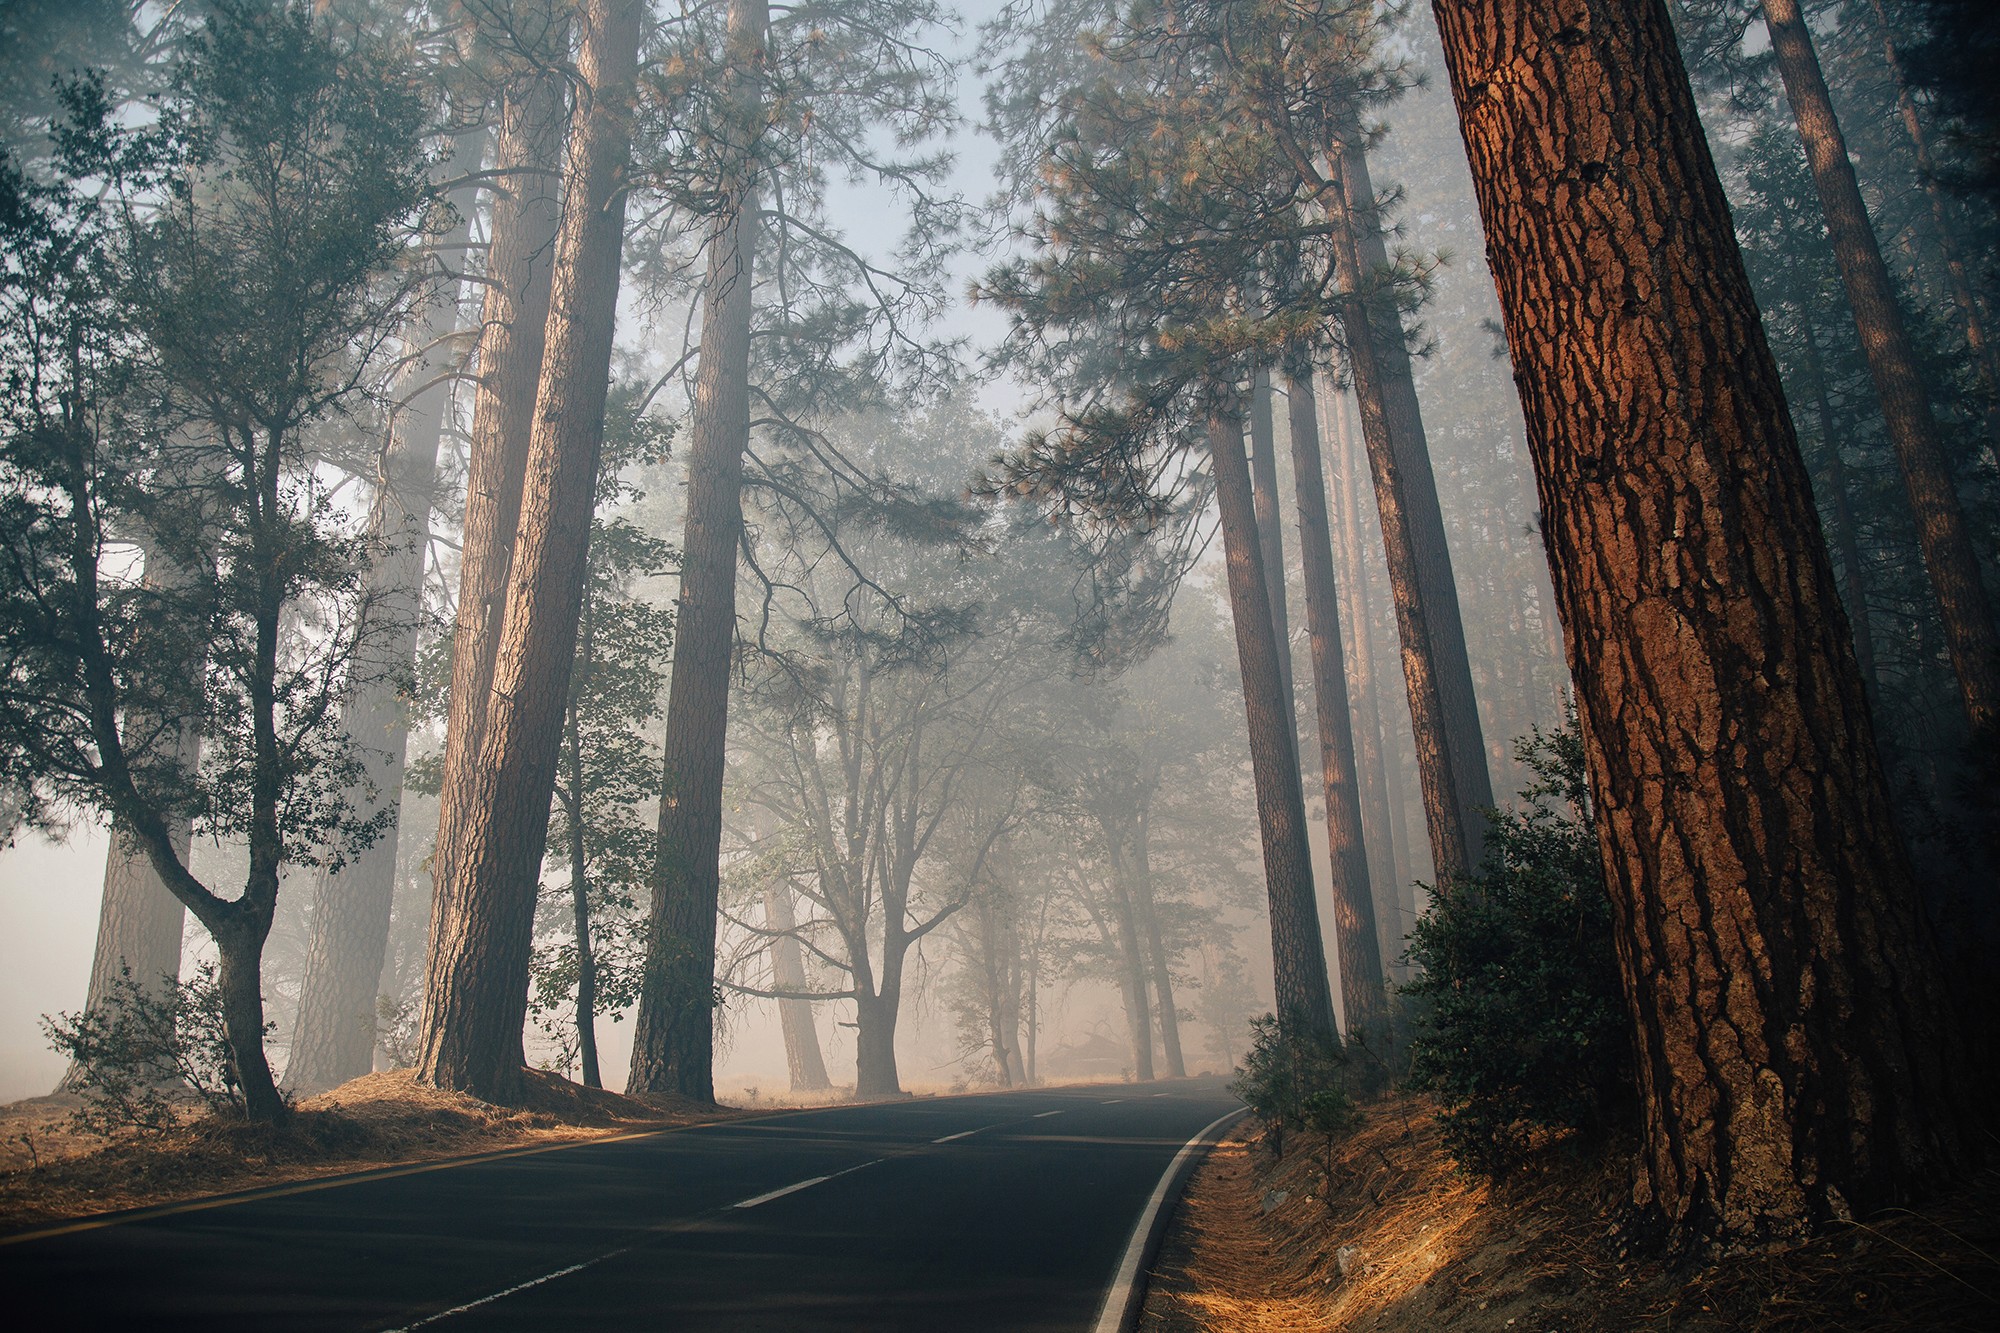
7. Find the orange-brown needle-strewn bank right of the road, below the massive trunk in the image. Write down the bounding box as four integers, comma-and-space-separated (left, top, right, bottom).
1140, 1097, 2000, 1333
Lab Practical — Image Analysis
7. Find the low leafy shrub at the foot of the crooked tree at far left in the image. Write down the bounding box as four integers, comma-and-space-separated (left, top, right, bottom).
42, 963, 272, 1135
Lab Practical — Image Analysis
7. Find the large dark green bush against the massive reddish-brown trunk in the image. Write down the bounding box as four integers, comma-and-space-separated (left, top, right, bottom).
1404, 719, 1632, 1175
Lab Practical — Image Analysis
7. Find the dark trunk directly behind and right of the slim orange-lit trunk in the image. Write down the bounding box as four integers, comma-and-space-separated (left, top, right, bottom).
1332, 122, 1494, 877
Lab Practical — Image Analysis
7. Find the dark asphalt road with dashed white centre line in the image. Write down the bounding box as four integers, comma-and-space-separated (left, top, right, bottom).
0, 1081, 1238, 1333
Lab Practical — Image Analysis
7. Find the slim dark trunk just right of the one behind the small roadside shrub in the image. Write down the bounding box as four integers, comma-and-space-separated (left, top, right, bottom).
1286, 362, 1388, 1055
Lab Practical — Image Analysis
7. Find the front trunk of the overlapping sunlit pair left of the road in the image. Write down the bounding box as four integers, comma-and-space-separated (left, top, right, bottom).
418, 0, 644, 1101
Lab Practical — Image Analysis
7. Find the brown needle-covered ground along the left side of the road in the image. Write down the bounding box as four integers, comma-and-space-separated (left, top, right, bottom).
0, 1069, 748, 1233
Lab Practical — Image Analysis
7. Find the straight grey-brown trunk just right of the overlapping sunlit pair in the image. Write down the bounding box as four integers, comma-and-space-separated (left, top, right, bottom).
628, 0, 770, 1101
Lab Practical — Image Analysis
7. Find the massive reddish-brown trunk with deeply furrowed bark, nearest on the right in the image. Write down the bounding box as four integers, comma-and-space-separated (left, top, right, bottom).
1436, 0, 1964, 1235
